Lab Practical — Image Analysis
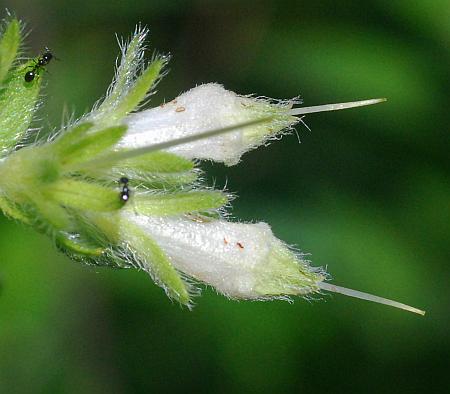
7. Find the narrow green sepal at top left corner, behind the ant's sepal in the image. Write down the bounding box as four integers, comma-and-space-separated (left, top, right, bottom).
0, 18, 21, 83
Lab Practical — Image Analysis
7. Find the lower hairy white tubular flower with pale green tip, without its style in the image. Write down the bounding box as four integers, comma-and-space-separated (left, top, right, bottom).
124, 213, 324, 299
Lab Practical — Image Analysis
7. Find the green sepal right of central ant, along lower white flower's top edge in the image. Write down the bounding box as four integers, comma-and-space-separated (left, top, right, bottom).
130, 191, 228, 216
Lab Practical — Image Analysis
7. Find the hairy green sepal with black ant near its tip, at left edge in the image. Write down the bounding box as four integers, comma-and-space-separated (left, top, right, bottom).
0, 60, 42, 154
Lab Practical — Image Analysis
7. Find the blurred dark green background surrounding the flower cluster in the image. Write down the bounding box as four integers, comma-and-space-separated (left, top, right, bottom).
0, 0, 450, 394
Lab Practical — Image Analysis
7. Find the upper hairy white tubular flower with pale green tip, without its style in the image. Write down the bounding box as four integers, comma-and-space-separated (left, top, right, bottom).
119, 83, 299, 165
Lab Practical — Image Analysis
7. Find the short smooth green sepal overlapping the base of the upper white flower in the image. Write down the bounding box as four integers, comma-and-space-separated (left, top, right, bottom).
56, 124, 127, 166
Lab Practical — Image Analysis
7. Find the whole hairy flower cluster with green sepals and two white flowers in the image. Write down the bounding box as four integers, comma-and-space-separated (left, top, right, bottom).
0, 18, 423, 313
